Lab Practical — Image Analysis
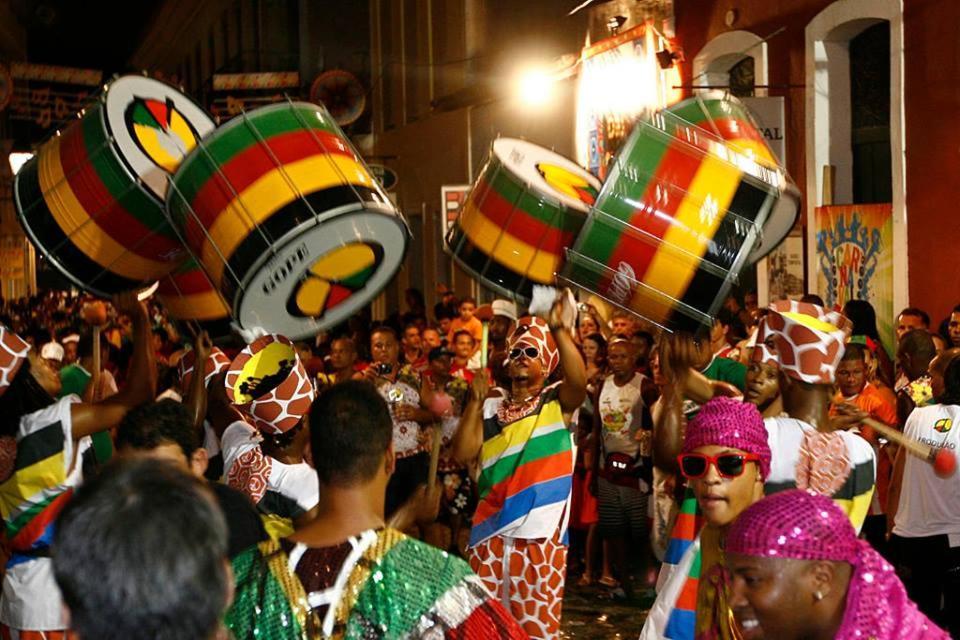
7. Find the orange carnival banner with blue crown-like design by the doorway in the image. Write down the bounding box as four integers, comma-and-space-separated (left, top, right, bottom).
814, 204, 895, 355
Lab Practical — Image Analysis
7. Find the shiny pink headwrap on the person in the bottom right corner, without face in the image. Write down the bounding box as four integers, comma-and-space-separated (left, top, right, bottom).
726, 490, 950, 640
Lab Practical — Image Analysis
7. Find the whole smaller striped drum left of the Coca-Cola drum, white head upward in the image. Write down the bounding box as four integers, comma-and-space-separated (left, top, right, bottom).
446, 138, 600, 299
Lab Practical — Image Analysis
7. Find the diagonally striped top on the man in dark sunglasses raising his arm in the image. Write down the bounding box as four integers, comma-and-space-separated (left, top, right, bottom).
470, 383, 574, 547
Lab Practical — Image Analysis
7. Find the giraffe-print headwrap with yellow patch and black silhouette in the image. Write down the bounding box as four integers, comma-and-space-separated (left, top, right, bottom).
224, 335, 316, 434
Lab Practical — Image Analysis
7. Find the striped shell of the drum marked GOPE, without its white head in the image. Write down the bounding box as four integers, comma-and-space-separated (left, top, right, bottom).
168, 103, 384, 300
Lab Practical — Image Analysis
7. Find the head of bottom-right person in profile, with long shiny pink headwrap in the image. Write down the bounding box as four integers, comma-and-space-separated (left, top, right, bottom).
726, 490, 950, 640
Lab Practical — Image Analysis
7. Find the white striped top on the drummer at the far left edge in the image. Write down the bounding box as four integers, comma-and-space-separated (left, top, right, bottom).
0, 395, 90, 630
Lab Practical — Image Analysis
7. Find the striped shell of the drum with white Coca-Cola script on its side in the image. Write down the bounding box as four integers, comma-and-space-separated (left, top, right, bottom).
564, 99, 777, 331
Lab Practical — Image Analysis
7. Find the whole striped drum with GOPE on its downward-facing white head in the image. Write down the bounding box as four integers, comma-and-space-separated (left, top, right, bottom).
167, 102, 409, 339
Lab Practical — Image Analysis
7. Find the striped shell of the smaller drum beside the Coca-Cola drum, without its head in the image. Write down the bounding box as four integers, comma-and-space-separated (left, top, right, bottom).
447, 156, 586, 298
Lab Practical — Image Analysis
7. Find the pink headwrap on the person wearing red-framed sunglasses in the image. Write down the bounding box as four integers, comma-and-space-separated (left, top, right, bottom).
683, 396, 770, 480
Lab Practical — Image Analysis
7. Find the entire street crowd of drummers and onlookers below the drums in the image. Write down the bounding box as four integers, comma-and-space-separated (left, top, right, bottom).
0, 290, 960, 640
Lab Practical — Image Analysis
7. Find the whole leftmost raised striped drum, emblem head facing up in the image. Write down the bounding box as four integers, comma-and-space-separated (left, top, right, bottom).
14, 76, 214, 296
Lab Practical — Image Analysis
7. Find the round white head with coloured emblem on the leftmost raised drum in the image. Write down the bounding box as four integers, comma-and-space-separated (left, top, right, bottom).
105, 76, 216, 202
